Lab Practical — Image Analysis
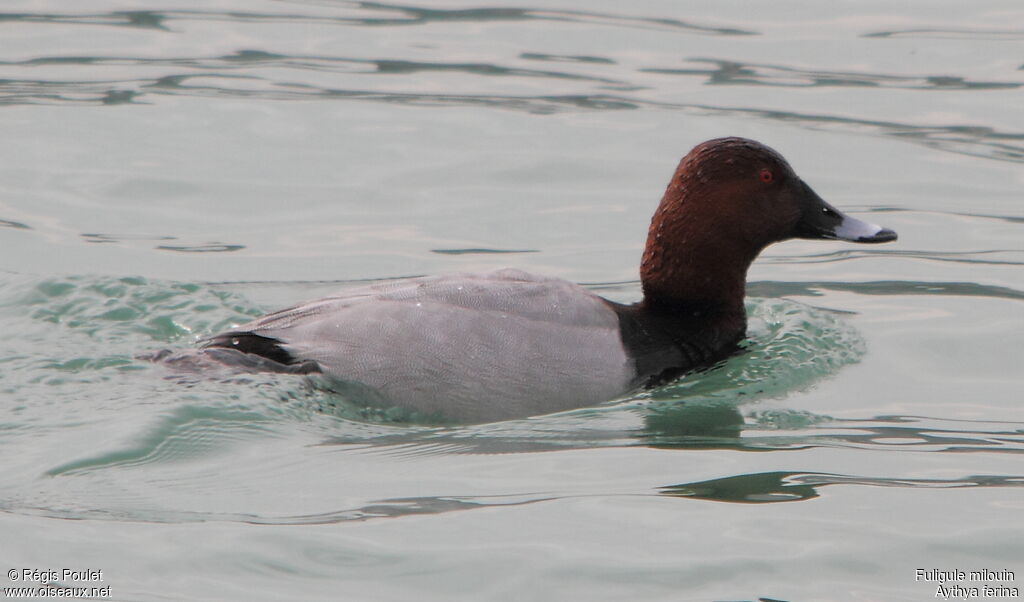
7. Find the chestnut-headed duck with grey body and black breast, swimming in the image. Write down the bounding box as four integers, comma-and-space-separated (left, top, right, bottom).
197, 137, 897, 423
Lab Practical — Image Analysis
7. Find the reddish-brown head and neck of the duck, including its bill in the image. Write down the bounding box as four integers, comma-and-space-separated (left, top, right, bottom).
640, 137, 896, 314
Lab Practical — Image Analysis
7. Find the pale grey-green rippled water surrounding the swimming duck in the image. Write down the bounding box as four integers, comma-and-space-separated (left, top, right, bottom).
0, 0, 1024, 601
